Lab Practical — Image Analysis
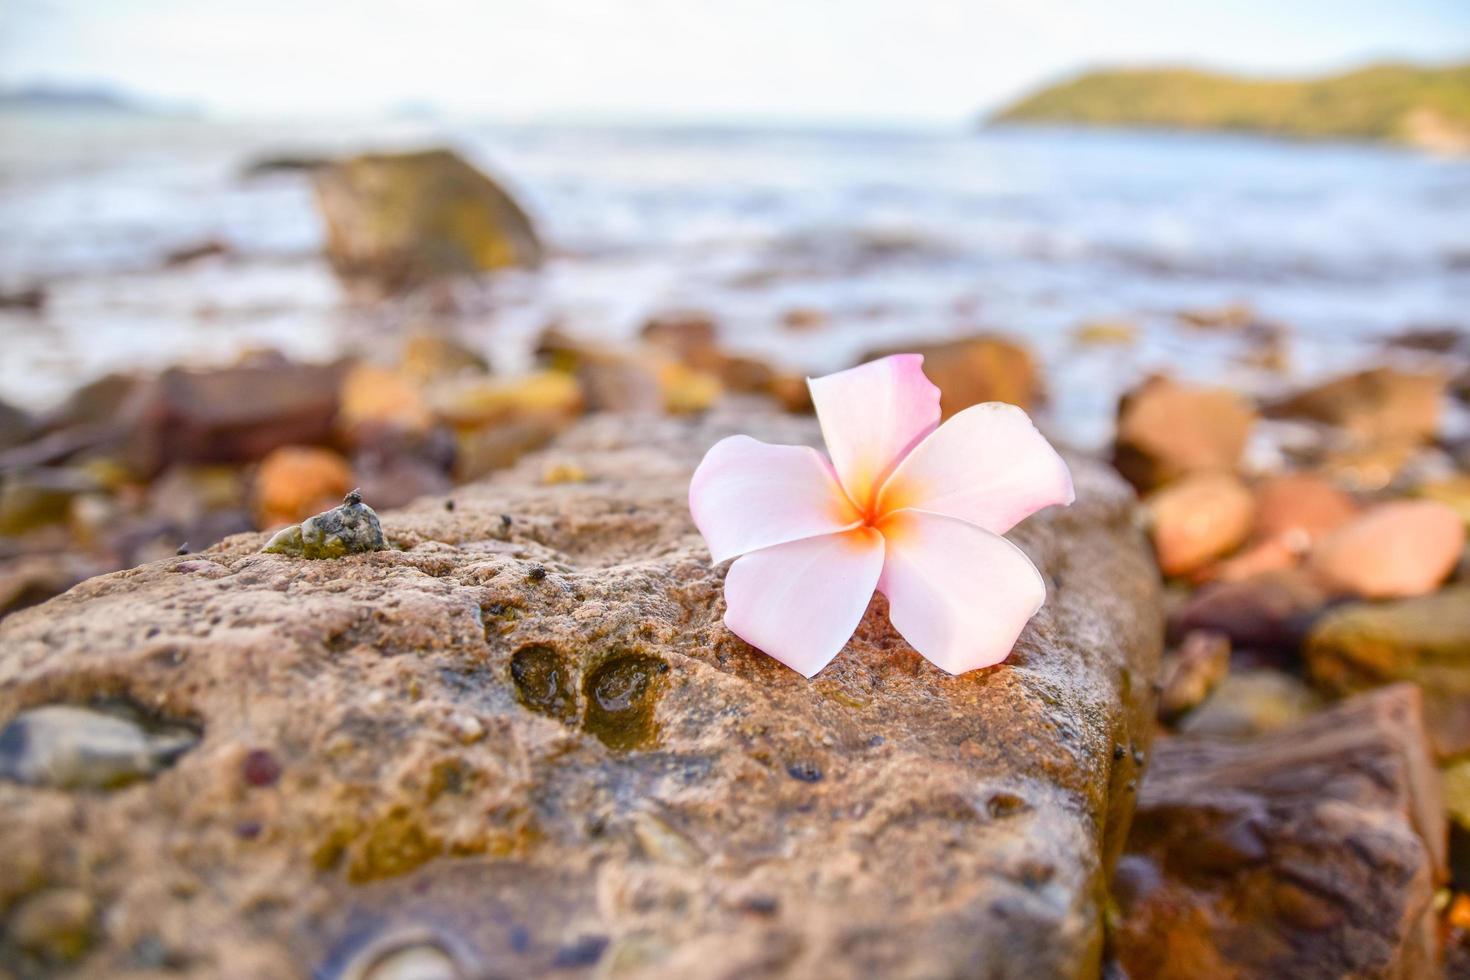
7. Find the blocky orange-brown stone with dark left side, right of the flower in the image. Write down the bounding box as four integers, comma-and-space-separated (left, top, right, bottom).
1113, 378, 1255, 491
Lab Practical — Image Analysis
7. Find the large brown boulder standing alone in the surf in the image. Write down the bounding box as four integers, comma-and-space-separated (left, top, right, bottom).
312, 150, 544, 291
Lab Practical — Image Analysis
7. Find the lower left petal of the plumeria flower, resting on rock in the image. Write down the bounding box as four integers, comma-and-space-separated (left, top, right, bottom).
725, 527, 883, 677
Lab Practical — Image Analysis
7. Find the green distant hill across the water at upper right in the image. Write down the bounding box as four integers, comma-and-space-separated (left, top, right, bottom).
989, 65, 1470, 153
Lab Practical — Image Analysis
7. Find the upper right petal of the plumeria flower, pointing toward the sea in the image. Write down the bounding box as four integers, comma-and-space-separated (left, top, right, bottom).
879, 401, 1075, 535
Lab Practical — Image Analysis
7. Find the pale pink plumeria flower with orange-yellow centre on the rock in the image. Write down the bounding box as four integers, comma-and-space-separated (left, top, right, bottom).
689, 354, 1073, 677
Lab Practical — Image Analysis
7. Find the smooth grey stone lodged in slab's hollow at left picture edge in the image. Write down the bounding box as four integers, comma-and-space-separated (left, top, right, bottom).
0, 704, 198, 789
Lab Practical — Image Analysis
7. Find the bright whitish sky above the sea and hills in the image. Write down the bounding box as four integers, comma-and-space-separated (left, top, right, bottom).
0, 0, 1470, 123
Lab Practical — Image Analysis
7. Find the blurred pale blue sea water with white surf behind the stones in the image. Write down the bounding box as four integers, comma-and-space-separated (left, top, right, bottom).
0, 116, 1470, 444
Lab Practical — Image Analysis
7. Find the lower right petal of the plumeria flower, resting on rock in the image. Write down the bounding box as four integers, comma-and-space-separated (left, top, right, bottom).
878, 510, 1047, 674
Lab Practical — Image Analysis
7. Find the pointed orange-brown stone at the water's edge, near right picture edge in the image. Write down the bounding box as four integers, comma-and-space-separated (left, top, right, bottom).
1267, 367, 1445, 444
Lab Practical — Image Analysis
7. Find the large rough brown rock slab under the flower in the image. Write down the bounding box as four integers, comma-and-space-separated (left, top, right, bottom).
0, 416, 1161, 980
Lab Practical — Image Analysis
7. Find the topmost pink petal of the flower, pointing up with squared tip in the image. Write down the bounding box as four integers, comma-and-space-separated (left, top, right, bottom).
807, 354, 939, 507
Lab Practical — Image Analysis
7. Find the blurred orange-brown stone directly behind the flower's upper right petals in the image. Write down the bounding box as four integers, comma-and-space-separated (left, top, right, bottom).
857, 334, 1045, 419
